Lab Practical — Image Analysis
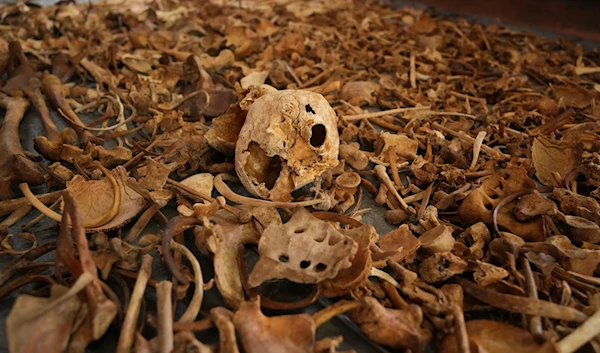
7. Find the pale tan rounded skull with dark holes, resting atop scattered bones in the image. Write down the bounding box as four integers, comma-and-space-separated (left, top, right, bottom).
235, 90, 339, 201
